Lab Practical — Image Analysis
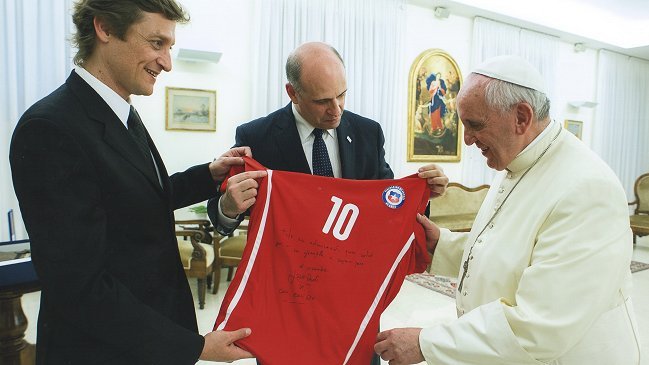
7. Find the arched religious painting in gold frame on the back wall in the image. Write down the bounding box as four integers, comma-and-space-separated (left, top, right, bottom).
408, 49, 462, 162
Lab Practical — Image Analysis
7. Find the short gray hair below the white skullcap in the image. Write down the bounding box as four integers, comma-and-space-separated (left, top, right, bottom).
485, 78, 550, 121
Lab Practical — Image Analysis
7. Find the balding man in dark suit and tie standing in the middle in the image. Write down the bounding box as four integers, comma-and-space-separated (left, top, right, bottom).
207, 42, 448, 364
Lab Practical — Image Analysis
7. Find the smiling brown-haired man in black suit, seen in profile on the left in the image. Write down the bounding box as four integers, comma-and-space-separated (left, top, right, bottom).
10, 0, 250, 365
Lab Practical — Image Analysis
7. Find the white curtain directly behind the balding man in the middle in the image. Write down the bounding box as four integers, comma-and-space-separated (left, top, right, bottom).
253, 0, 406, 176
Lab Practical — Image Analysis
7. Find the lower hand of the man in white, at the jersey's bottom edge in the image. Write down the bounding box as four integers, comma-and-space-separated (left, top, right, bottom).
374, 328, 425, 365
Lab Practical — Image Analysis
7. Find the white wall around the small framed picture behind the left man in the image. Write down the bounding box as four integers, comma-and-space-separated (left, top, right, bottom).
133, 0, 254, 174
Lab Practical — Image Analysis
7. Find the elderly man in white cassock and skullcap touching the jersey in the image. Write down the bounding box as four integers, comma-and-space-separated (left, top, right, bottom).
375, 56, 640, 365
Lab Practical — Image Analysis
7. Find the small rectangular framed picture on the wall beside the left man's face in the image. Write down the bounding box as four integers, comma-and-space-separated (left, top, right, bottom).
165, 87, 216, 132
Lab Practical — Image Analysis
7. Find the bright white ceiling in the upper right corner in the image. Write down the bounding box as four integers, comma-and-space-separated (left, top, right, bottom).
410, 0, 649, 60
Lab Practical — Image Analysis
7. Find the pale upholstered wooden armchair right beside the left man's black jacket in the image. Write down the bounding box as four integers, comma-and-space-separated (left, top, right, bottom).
176, 230, 215, 309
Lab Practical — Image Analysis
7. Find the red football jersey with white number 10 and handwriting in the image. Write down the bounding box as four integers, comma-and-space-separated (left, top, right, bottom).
214, 158, 430, 365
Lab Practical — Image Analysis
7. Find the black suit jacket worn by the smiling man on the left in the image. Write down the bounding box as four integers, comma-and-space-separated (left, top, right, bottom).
10, 72, 215, 365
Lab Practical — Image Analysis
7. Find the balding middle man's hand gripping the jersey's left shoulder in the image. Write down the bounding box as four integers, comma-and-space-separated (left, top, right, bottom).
220, 171, 268, 218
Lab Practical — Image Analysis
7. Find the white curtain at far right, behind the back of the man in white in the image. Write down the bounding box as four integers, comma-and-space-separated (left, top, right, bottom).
593, 50, 649, 196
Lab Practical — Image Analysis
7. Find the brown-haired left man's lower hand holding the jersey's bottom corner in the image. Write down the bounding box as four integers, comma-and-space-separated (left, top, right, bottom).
199, 328, 253, 362
